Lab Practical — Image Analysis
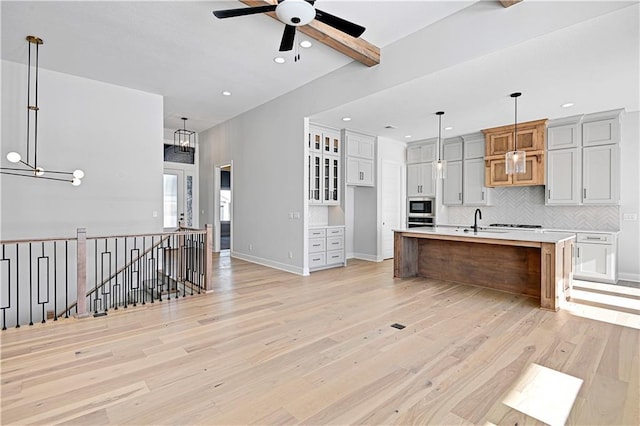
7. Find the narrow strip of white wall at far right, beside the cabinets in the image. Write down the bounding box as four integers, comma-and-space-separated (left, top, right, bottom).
618, 111, 640, 281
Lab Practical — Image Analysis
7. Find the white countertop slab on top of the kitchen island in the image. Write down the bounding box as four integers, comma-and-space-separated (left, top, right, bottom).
394, 226, 576, 244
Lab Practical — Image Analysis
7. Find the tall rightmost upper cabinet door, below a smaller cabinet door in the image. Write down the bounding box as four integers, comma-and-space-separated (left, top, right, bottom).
582, 145, 620, 204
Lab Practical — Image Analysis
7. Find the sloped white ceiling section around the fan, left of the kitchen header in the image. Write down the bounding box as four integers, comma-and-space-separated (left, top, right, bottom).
0, 0, 473, 131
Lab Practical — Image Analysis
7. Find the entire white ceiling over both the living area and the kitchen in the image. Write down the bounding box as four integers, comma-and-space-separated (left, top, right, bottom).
0, 0, 640, 140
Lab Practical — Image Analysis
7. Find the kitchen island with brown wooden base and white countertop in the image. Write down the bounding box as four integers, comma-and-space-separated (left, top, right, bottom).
394, 227, 575, 311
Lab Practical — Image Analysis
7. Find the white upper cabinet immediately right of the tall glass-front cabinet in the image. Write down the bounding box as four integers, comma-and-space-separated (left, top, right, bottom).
343, 130, 376, 186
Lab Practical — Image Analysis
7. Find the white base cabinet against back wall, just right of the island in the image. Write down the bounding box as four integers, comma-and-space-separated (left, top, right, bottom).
574, 232, 618, 284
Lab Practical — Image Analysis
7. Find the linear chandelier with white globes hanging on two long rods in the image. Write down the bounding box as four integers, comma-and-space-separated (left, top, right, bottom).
0, 36, 84, 186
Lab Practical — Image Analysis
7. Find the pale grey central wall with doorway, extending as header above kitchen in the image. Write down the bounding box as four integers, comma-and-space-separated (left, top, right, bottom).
200, 2, 636, 273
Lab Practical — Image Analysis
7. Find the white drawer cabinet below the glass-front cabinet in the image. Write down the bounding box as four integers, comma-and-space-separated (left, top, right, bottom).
309, 226, 345, 270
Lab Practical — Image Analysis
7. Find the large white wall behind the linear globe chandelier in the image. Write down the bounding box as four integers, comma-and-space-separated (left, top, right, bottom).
0, 61, 163, 239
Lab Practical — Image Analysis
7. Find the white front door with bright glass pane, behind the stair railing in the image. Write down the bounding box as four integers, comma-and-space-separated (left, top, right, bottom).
162, 169, 193, 231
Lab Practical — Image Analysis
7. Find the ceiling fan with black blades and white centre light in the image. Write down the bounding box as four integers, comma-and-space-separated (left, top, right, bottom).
213, 0, 365, 52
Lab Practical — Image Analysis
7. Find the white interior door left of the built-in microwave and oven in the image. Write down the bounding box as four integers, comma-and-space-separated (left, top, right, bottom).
380, 161, 404, 259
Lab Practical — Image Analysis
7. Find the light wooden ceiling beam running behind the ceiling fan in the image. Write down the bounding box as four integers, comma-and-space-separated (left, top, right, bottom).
239, 0, 380, 67
